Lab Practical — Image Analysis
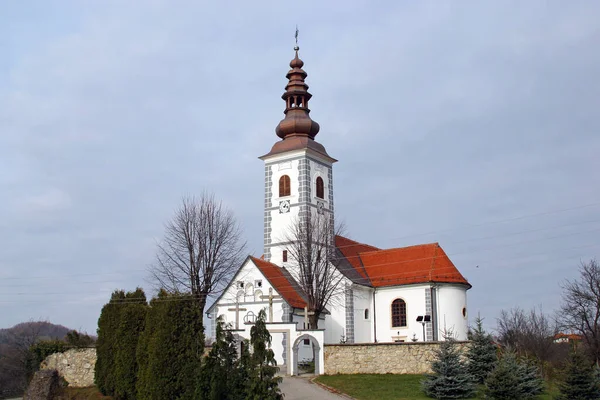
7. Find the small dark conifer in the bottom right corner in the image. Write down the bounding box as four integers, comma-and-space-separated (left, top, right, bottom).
558, 351, 600, 400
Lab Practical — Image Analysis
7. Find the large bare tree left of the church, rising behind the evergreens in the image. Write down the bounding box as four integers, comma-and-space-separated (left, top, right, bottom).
151, 193, 246, 310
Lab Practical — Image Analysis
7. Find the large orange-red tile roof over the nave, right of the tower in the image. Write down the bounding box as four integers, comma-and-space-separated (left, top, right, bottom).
336, 236, 471, 287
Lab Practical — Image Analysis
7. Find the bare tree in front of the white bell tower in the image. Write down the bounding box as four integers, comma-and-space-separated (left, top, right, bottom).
286, 214, 345, 329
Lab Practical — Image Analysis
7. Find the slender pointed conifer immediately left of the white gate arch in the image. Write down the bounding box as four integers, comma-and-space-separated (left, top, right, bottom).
246, 309, 283, 400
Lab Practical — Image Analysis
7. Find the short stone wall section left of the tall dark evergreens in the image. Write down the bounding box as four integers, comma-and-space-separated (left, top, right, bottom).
40, 348, 96, 387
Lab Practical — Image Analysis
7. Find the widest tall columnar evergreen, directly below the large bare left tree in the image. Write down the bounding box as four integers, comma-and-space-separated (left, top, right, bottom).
137, 290, 204, 400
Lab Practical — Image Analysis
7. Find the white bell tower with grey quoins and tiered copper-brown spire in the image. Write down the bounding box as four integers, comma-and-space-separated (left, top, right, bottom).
259, 45, 337, 265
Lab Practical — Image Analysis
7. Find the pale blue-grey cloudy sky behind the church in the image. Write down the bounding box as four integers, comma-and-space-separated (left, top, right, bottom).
0, 0, 600, 333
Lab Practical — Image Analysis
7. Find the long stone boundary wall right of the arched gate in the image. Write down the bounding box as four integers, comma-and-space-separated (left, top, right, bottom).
325, 342, 469, 375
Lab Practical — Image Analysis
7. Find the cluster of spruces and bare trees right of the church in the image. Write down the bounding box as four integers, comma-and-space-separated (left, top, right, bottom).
422, 260, 600, 400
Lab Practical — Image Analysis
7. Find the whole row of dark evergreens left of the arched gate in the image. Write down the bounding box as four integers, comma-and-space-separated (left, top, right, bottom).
95, 288, 282, 400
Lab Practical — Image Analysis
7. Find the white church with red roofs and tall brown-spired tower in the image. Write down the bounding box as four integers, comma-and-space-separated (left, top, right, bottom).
206, 46, 471, 374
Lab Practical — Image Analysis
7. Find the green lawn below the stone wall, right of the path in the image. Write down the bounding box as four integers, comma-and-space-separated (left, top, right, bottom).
316, 374, 556, 400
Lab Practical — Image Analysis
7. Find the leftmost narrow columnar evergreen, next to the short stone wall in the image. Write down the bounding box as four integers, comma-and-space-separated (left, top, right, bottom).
94, 290, 125, 396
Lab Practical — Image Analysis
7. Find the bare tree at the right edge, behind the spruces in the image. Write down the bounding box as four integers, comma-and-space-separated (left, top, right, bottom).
557, 259, 600, 365
